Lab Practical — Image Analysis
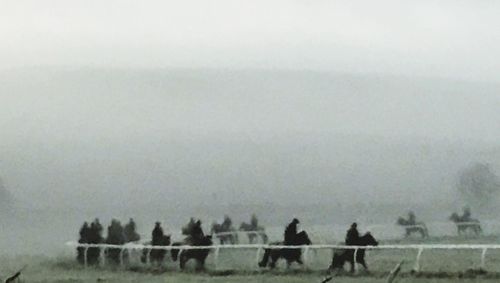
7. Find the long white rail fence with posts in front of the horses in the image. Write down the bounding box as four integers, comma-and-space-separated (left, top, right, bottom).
66, 242, 500, 272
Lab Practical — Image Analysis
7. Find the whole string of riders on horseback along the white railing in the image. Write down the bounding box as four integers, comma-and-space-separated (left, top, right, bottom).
77, 208, 474, 270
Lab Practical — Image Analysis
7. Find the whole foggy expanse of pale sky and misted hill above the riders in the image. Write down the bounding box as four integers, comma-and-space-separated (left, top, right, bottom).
0, 0, 500, 212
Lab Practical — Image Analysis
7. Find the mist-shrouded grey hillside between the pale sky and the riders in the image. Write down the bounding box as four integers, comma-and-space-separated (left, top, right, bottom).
0, 69, 500, 214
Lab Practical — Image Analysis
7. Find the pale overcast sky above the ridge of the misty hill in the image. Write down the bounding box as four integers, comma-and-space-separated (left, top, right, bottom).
0, 0, 500, 80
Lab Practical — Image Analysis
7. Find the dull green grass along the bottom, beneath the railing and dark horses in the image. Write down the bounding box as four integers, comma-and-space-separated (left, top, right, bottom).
4, 237, 500, 283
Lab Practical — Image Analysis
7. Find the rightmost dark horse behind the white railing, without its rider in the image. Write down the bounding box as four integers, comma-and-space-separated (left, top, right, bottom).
328, 232, 378, 272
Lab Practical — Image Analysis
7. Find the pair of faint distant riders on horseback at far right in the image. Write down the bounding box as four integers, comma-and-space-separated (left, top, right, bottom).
397, 206, 482, 238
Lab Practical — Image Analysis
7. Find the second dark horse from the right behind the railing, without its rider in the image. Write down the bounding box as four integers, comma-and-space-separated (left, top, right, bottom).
259, 231, 312, 268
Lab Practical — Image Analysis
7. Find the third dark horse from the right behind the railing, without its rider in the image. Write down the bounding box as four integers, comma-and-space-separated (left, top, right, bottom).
170, 235, 213, 270
